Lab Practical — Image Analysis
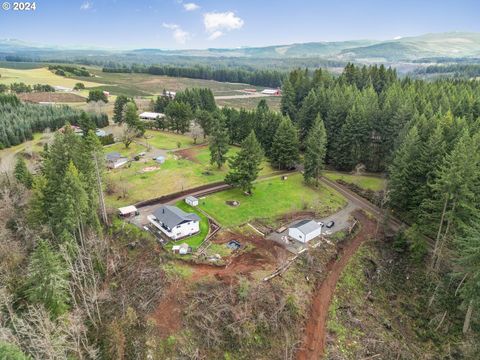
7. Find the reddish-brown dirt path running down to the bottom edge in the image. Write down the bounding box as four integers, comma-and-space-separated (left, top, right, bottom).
297, 211, 377, 360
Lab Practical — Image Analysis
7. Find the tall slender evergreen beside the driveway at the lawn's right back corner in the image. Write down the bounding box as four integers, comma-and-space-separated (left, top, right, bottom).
303, 115, 327, 185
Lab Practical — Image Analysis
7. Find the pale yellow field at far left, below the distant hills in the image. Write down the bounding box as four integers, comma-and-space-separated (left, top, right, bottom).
0, 67, 101, 88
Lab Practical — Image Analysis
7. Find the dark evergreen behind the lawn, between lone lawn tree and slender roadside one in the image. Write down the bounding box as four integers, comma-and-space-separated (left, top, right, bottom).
270, 117, 299, 170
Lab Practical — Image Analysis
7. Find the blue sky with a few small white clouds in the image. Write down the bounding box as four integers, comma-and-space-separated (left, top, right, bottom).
0, 0, 480, 49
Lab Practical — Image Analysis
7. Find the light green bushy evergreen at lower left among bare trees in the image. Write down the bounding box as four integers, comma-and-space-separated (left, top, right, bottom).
26, 240, 69, 317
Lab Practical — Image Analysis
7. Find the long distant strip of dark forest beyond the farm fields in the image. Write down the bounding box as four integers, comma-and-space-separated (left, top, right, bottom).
103, 65, 285, 87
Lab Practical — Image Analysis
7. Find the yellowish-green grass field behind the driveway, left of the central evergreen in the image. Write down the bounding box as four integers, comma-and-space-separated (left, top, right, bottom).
105, 144, 274, 207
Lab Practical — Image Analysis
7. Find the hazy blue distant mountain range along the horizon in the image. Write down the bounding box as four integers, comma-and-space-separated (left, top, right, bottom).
0, 32, 480, 63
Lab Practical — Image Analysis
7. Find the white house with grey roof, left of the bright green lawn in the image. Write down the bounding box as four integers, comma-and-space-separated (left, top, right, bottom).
147, 205, 200, 240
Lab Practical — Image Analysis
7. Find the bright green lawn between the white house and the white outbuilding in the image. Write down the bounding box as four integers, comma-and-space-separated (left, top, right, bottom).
199, 174, 347, 227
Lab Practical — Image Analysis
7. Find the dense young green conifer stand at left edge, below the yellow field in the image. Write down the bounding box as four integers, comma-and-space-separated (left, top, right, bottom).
0, 94, 108, 149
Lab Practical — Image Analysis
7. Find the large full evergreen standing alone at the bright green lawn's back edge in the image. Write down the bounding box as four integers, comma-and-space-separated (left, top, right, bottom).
225, 131, 263, 194
